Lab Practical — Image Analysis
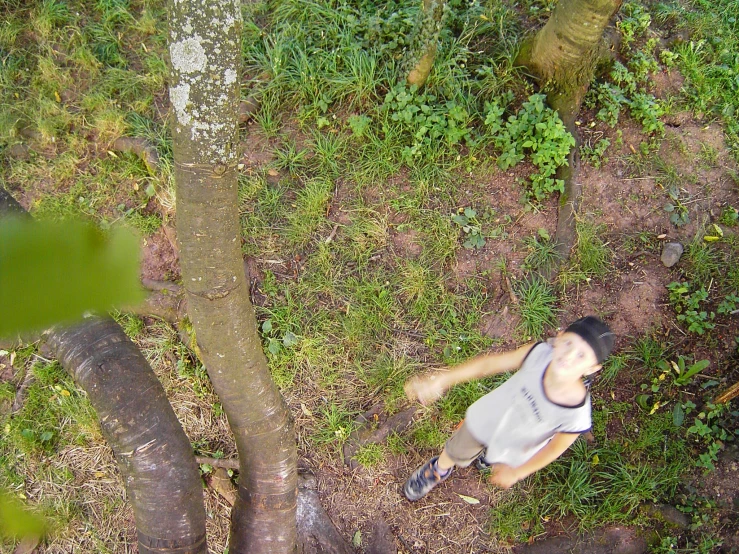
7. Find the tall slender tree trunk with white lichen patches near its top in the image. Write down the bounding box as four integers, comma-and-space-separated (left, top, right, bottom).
169, 0, 297, 554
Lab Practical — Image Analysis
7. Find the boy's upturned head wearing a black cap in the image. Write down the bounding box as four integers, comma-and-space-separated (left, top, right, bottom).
552, 316, 616, 376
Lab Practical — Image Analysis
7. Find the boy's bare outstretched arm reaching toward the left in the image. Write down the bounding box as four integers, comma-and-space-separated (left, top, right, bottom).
405, 343, 534, 405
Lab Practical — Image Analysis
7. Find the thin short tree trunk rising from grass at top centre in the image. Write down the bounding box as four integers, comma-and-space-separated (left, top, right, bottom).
404, 0, 446, 87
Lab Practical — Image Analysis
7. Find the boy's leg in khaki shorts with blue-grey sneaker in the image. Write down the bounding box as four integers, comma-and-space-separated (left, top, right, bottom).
403, 418, 485, 500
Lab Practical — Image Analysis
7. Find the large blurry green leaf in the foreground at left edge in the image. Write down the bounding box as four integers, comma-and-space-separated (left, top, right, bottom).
0, 219, 144, 336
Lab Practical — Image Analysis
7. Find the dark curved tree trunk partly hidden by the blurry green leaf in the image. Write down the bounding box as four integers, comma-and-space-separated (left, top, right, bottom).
0, 188, 208, 554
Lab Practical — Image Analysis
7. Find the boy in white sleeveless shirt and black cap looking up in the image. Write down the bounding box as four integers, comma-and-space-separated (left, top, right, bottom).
403, 316, 615, 500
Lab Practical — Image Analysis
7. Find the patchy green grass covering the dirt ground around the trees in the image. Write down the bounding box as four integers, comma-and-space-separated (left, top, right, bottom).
0, 0, 739, 551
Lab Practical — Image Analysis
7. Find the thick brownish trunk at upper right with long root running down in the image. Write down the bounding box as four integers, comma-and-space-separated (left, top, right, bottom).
517, 0, 623, 258
